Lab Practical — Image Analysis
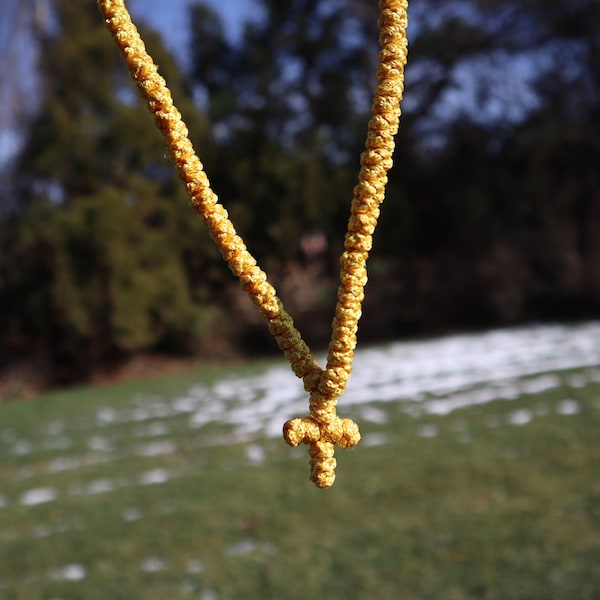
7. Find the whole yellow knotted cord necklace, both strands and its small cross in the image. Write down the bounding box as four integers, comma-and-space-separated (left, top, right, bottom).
98, 0, 408, 488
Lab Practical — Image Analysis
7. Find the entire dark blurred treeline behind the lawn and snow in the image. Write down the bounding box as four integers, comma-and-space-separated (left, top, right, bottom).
0, 0, 600, 383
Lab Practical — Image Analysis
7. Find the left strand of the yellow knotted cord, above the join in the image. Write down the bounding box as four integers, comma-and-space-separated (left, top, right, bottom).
98, 0, 323, 391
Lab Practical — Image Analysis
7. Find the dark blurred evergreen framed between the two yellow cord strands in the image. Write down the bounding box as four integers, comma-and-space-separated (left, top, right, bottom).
190, 0, 377, 269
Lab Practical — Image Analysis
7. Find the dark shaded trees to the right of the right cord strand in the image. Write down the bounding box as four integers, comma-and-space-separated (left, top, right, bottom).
380, 0, 600, 328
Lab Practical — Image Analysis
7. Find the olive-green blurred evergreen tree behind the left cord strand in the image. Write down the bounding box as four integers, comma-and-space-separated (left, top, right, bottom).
5, 0, 217, 381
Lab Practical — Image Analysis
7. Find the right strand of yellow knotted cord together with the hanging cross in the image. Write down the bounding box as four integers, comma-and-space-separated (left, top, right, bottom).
284, 0, 408, 488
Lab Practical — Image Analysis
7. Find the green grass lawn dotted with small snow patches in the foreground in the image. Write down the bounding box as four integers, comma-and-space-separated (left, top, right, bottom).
0, 354, 600, 600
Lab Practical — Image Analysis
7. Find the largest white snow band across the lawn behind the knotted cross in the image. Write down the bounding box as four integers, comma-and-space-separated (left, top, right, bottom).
179, 322, 600, 439
